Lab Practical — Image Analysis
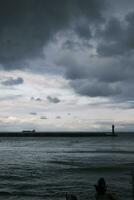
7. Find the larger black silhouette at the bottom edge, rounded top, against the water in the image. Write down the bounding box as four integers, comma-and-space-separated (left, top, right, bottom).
95, 178, 115, 200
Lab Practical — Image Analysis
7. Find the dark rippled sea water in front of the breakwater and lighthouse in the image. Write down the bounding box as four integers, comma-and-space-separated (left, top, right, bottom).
0, 134, 134, 200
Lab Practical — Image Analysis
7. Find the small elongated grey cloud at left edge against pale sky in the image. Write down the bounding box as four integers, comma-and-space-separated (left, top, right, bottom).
1, 77, 24, 86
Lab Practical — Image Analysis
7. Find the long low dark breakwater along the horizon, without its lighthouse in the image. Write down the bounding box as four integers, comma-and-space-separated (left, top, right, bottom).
0, 131, 117, 137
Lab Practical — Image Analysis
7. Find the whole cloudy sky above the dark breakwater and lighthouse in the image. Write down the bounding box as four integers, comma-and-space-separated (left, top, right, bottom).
0, 0, 134, 131
